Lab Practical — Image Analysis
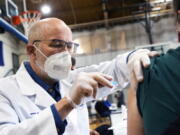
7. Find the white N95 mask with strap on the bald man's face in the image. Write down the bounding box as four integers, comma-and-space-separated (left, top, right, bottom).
34, 46, 72, 80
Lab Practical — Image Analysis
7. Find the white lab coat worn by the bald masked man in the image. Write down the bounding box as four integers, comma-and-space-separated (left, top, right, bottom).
0, 54, 129, 135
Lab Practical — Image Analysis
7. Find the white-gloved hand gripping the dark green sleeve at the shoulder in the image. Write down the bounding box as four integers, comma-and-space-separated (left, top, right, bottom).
128, 49, 159, 82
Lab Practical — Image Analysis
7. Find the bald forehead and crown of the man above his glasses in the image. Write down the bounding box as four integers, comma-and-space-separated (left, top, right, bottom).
28, 18, 72, 42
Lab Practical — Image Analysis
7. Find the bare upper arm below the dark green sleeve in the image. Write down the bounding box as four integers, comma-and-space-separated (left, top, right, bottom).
128, 74, 144, 135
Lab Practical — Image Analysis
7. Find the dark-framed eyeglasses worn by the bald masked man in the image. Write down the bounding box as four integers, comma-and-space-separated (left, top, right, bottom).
33, 39, 79, 52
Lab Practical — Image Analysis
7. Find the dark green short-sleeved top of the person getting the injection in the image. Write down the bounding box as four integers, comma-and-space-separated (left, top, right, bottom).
137, 47, 180, 135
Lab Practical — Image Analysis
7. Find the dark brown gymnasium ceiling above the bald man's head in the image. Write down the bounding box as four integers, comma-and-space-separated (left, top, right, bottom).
14, 0, 173, 30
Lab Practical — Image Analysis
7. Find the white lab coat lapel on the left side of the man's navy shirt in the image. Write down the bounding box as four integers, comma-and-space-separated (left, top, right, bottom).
15, 63, 56, 107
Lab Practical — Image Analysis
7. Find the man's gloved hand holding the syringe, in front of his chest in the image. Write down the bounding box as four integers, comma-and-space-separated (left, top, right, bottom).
69, 72, 113, 105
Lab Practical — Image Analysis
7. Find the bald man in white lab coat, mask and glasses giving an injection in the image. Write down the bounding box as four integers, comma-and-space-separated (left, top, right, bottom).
0, 18, 156, 135
